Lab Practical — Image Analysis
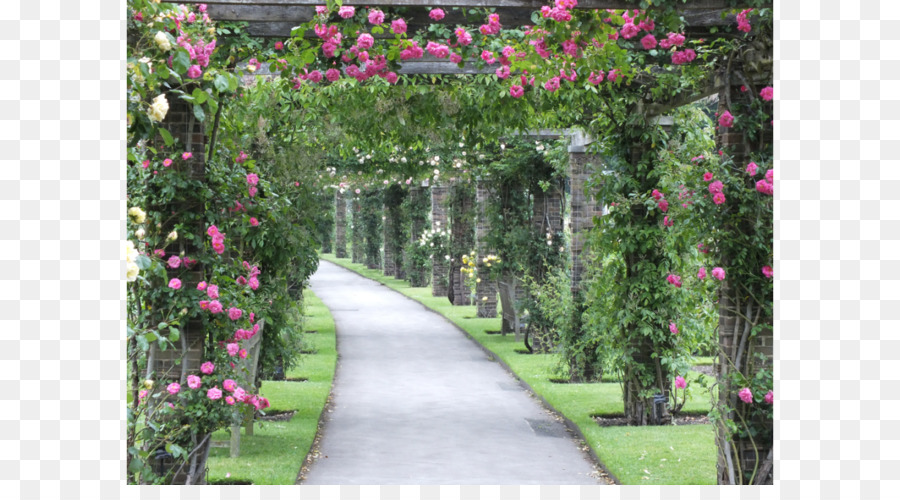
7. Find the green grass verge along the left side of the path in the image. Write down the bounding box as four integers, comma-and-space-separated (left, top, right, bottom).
208, 290, 337, 484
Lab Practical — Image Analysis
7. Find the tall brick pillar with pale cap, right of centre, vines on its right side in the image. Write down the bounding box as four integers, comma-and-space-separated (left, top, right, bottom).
569, 144, 602, 292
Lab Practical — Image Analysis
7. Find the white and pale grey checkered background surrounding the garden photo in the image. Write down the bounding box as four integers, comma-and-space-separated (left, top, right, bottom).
0, 0, 900, 500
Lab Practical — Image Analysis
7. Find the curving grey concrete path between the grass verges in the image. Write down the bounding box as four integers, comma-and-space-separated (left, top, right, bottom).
303, 261, 598, 484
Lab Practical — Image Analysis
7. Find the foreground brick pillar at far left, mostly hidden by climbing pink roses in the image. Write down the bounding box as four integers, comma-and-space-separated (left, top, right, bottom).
148, 94, 206, 382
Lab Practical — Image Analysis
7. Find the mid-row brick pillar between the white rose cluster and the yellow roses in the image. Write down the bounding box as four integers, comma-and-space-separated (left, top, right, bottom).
447, 184, 475, 306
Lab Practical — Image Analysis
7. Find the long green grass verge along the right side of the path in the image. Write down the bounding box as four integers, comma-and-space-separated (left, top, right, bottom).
319, 254, 716, 484
